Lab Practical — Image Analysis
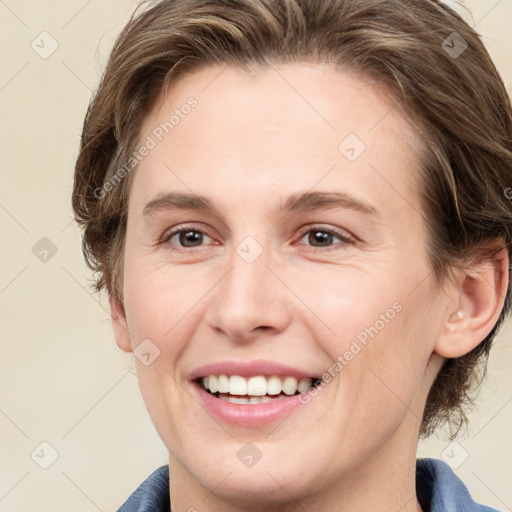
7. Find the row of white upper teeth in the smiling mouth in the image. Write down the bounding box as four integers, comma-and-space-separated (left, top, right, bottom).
203, 375, 313, 396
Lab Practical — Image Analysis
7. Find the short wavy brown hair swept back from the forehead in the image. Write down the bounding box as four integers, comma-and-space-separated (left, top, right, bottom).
72, 0, 512, 437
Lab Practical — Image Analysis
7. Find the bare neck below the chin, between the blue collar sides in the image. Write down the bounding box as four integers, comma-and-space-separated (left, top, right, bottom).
169, 414, 421, 512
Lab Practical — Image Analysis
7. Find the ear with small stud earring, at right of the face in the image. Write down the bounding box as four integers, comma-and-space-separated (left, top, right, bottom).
434, 249, 509, 358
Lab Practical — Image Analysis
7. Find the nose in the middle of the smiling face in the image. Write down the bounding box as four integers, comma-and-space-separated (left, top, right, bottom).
206, 241, 291, 343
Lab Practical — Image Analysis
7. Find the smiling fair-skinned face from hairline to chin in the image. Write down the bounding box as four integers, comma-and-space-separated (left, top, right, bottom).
117, 64, 443, 502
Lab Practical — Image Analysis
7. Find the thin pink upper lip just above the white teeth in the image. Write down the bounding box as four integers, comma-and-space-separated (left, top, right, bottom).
188, 360, 319, 381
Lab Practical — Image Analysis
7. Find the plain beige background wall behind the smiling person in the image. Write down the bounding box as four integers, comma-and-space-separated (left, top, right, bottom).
0, 0, 512, 512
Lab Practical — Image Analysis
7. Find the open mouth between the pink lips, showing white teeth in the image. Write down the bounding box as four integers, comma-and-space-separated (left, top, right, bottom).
195, 374, 321, 405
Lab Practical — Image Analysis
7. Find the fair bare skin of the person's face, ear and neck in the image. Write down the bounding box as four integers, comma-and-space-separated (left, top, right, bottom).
111, 63, 508, 512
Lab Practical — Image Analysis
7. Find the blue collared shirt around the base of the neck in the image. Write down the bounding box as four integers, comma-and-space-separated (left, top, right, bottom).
117, 459, 498, 512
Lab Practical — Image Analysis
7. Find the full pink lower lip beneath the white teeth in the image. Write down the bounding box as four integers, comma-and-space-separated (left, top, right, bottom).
192, 382, 304, 428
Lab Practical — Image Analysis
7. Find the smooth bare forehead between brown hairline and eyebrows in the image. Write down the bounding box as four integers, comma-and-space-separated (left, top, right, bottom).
134, 63, 420, 214
